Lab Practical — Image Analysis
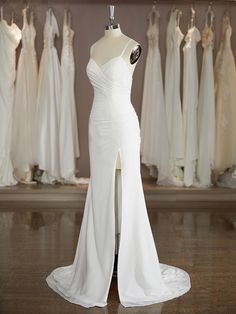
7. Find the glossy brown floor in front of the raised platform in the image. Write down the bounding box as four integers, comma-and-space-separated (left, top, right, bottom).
0, 209, 236, 314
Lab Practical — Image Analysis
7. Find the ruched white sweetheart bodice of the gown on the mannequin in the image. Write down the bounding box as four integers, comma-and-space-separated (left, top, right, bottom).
87, 41, 135, 120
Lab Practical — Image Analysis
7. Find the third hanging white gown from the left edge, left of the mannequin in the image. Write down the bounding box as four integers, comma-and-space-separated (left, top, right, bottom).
37, 8, 61, 183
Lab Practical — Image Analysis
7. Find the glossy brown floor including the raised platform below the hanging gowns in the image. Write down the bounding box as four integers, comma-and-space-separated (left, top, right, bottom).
0, 178, 236, 314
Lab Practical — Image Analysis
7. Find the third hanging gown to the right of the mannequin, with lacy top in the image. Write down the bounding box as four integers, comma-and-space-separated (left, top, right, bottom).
183, 26, 201, 187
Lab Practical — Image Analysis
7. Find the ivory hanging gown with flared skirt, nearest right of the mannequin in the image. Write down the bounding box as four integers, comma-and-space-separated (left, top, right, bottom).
140, 9, 171, 184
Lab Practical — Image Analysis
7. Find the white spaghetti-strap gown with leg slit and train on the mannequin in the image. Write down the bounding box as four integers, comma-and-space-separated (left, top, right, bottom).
46, 39, 190, 308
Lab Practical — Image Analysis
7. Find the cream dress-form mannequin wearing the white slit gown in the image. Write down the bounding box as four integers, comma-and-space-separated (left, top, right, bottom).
90, 5, 142, 276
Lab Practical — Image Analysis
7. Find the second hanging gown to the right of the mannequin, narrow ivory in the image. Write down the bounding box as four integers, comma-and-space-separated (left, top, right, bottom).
165, 9, 184, 180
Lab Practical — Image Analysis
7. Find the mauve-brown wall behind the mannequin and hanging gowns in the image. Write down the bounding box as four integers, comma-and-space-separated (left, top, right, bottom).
0, 0, 236, 177
